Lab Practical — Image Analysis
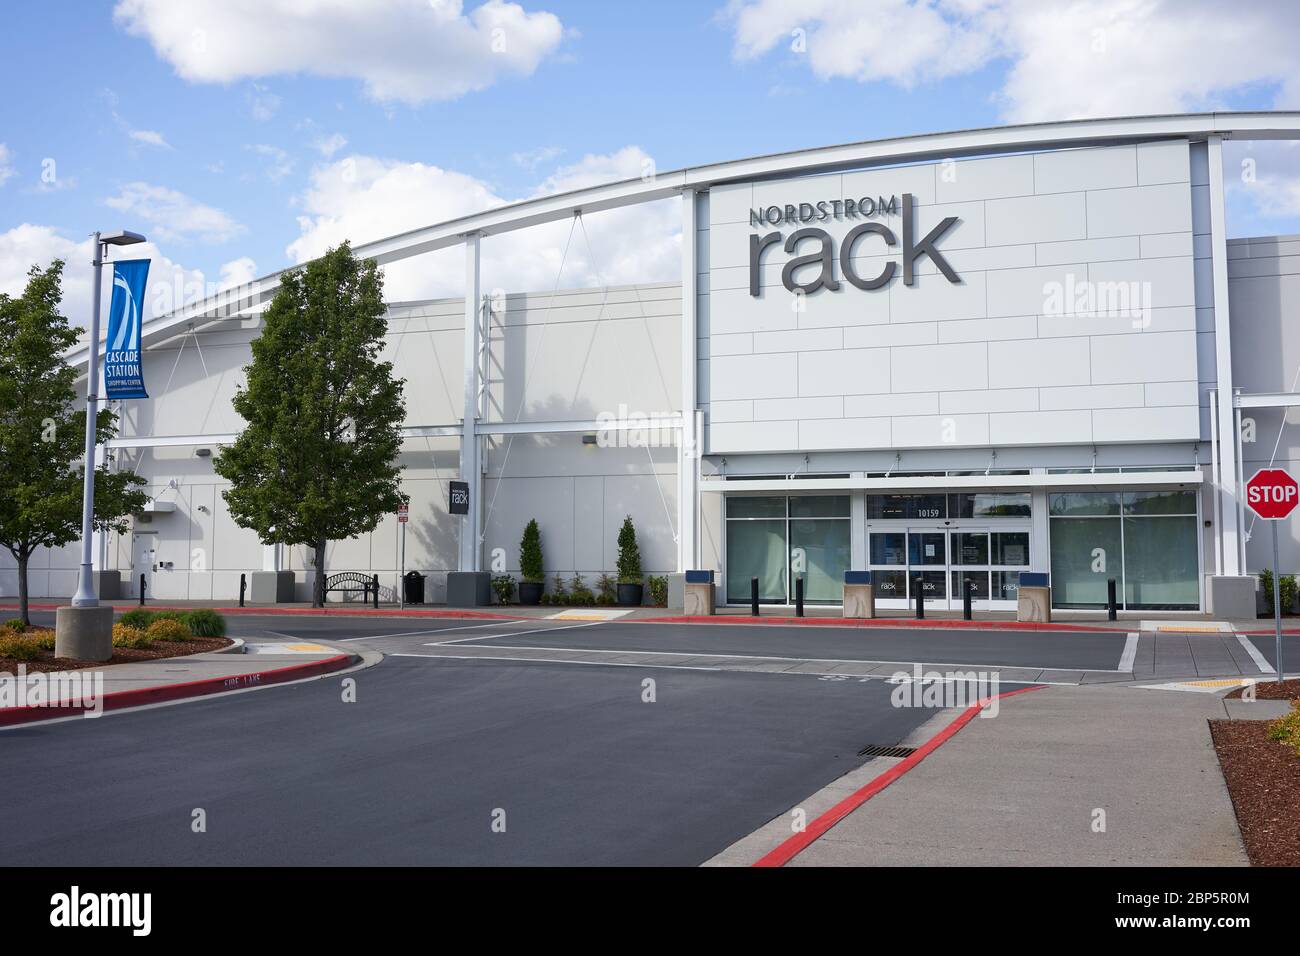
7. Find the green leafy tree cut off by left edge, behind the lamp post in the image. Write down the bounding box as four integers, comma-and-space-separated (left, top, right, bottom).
0, 259, 148, 624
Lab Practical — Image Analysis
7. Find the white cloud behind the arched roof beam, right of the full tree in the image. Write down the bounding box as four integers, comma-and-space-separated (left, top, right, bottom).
287, 146, 681, 300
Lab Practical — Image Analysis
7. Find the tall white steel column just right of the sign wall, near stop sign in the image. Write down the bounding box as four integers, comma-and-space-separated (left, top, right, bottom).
1208, 137, 1244, 575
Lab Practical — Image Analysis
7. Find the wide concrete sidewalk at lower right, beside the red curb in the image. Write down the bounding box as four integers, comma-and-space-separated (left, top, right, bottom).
710, 685, 1278, 866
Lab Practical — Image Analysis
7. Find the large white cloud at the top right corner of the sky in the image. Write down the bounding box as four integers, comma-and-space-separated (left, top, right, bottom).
723, 0, 1300, 122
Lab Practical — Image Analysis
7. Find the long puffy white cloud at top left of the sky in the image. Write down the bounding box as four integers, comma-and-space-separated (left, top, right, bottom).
113, 0, 563, 103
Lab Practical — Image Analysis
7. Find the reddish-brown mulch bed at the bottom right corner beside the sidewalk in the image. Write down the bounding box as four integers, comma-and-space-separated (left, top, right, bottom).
1210, 717, 1300, 866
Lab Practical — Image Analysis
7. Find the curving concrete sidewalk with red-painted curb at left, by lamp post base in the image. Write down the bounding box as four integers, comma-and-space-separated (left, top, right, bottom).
0, 641, 361, 728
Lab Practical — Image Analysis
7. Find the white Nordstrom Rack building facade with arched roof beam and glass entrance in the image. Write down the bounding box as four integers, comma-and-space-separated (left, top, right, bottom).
0, 113, 1300, 617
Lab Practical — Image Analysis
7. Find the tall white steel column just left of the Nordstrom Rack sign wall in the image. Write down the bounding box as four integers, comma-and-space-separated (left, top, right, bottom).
677, 189, 701, 571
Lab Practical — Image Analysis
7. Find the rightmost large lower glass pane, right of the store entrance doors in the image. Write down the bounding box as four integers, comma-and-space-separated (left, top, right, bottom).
1123, 515, 1201, 610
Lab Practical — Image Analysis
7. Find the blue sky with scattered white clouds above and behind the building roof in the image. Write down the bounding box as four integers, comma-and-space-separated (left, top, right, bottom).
0, 0, 1300, 325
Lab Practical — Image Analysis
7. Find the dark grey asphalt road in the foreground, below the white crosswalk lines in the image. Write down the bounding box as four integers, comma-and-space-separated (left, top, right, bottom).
0, 658, 933, 865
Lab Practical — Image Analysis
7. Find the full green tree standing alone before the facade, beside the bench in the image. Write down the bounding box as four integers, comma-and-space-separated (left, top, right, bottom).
216, 242, 406, 607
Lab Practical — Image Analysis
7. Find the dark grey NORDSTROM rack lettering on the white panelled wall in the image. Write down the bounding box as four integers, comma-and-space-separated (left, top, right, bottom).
749, 193, 961, 297
